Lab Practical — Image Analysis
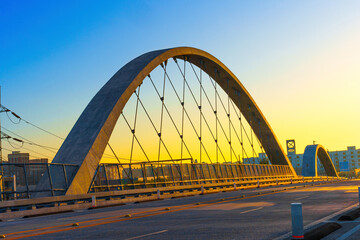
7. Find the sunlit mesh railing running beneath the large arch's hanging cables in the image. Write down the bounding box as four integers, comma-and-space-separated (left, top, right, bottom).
89, 161, 293, 192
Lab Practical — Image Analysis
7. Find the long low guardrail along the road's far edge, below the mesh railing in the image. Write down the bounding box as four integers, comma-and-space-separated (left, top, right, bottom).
0, 177, 342, 219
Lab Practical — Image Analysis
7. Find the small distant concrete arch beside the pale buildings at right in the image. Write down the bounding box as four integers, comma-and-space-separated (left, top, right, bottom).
302, 144, 338, 177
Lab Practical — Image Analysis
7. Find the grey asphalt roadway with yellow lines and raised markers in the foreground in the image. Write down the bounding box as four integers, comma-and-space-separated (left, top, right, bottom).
0, 181, 360, 240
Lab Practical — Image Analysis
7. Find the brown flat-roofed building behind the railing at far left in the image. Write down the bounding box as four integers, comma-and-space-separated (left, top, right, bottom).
4, 151, 49, 186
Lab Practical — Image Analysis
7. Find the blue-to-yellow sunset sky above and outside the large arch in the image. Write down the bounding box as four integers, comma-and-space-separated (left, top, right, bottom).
0, 0, 360, 161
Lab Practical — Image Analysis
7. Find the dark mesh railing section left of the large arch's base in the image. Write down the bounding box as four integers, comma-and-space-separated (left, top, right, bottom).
0, 163, 78, 201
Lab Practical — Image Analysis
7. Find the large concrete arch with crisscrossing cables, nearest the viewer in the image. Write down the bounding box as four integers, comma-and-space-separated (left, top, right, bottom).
49, 47, 296, 194
